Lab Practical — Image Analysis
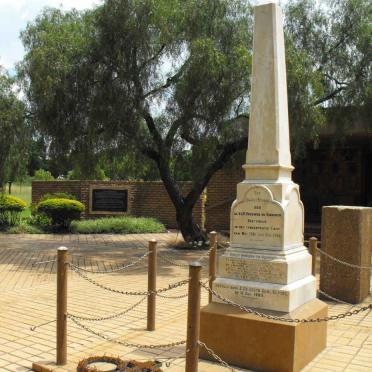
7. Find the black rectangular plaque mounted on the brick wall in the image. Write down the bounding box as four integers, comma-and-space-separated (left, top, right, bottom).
92, 189, 128, 212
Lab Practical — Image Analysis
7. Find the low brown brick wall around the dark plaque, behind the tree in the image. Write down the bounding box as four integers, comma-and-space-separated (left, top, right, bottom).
32, 181, 203, 229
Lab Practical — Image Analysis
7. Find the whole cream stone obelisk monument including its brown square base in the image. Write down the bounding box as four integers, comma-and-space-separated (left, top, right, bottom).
200, 3, 327, 371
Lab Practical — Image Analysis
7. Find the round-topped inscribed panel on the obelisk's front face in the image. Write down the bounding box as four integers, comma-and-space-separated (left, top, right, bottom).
231, 186, 284, 247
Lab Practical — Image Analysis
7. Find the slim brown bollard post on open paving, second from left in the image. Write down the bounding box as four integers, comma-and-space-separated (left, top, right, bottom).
147, 240, 157, 331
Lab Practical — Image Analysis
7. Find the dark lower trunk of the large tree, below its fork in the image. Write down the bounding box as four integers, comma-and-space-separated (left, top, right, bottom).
176, 206, 208, 247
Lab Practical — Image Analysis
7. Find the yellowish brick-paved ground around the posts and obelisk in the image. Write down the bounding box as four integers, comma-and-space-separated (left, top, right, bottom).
0, 232, 372, 372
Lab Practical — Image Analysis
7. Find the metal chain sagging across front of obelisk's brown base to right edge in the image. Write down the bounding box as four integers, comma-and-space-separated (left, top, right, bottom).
200, 282, 372, 323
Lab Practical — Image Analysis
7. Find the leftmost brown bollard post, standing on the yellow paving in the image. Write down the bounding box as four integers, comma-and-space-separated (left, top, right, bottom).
57, 247, 68, 365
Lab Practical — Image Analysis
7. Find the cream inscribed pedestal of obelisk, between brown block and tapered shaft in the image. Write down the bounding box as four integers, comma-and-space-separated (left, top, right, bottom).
218, 180, 316, 312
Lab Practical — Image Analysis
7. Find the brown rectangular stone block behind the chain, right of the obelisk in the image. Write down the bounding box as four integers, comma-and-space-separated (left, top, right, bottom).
320, 206, 372, 304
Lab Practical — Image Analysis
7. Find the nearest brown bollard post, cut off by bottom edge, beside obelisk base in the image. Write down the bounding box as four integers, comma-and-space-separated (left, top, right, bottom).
185, 262, 202, 372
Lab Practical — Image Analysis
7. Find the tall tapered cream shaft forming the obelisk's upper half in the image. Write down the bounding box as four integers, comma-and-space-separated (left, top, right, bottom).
244, 1, 293, 180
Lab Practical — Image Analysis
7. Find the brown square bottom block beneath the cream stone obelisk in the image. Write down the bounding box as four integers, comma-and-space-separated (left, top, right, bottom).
200, 299, 328, 372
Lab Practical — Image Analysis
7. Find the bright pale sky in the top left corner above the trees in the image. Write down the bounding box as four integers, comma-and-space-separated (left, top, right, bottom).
0, 0, 285, 73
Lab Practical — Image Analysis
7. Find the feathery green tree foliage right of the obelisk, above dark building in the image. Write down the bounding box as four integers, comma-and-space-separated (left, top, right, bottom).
286, 0, 372, 150
